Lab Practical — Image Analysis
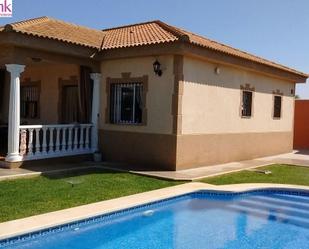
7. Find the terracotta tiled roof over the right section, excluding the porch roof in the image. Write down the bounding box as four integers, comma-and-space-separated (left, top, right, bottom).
102, 21, 308, 77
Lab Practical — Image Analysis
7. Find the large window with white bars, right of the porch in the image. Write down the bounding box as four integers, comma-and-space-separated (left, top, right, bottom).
110, 83, 143, 124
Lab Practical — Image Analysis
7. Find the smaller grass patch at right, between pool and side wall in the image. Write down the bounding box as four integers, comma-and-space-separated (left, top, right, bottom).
201, 164, 309, 186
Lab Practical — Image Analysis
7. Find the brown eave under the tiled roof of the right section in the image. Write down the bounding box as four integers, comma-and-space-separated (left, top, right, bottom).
97, 41, 308, 83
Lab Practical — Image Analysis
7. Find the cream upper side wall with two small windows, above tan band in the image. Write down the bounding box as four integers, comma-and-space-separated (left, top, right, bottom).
182, 57, 294, 134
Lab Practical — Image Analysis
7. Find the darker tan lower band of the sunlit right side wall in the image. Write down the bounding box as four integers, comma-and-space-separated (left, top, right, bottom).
176, 132, 293, 170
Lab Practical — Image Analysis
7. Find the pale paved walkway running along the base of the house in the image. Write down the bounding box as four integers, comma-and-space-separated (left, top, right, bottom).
0, 151, 309, 181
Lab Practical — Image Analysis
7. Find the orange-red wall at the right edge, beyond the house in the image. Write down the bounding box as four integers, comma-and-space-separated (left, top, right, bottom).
294, 100, 309, 149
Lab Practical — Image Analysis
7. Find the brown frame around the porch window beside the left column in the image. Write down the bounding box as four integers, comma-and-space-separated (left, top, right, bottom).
20, 78, 41, 120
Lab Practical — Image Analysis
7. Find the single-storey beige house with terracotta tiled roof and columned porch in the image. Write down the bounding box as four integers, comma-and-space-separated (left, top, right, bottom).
0, 17, 308, 170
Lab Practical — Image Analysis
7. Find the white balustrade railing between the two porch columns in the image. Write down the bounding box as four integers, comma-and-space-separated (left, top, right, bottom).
19, 124, 92, 160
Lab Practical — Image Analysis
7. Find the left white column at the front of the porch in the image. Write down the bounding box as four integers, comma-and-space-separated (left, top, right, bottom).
5, 64, 25, 162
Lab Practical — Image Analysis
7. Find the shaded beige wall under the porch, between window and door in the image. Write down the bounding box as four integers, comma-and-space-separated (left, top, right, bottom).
21, 64, 79, 124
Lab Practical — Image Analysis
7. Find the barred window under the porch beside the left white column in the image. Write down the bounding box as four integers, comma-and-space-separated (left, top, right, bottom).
20, 86, 40, 119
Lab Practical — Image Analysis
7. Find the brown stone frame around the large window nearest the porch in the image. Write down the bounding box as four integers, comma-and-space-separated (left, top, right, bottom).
104, 72, 148, 126
